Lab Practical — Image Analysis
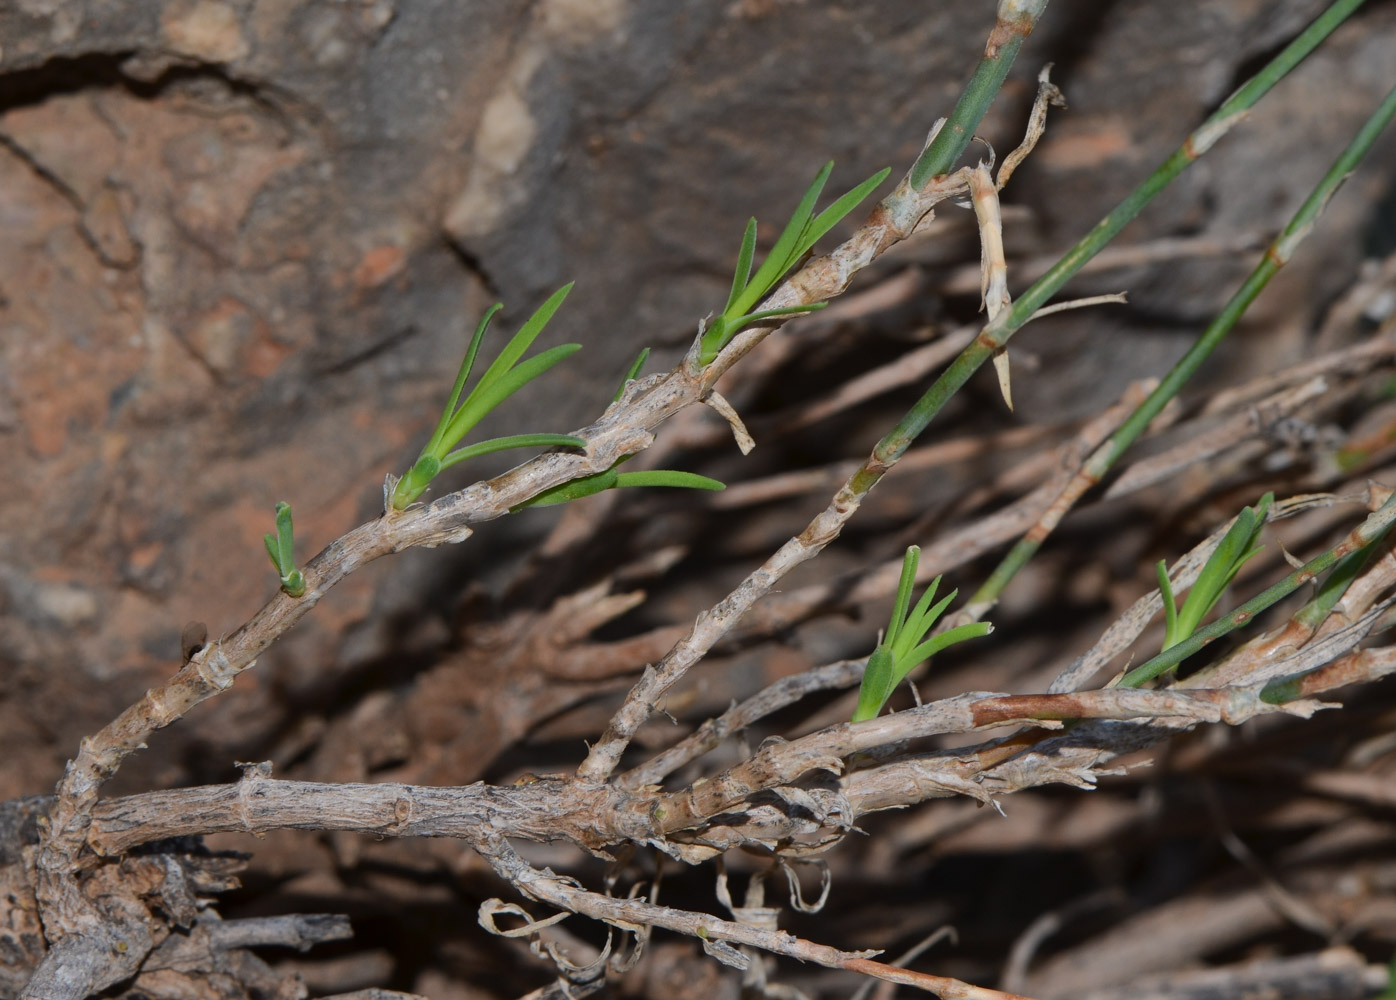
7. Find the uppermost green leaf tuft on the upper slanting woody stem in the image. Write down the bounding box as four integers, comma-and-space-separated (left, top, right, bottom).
698, 161, 892, 365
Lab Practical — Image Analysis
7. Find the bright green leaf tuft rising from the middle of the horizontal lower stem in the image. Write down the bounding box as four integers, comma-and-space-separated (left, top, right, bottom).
853, 545, 994, 722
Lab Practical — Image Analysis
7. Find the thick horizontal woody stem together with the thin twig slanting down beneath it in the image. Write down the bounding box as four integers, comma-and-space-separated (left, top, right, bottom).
38, 491, 1396, 996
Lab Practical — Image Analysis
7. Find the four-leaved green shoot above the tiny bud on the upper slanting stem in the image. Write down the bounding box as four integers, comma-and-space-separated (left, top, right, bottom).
392, 285, 586, 510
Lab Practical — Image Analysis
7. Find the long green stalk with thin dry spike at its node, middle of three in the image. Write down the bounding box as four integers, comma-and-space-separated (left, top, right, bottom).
850, 0, 1362, 493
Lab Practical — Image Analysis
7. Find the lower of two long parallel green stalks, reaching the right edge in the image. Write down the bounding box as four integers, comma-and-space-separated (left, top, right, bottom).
966, 74, 1396, 606
